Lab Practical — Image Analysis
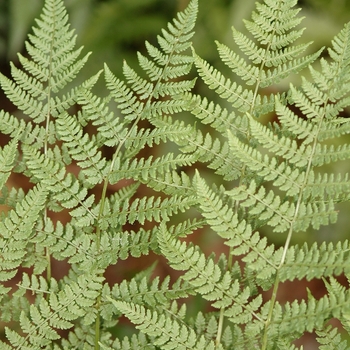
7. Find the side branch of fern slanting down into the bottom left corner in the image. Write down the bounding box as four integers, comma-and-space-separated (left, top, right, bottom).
6, 274, 101, 349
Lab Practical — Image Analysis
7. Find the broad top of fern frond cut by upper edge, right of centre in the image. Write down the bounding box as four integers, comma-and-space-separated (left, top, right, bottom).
194, 1, 321, 126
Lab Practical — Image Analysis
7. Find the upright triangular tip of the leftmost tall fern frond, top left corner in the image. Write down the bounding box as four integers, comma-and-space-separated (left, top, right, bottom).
0, 0, 89, 123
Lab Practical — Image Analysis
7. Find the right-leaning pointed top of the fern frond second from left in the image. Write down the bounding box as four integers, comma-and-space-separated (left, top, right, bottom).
105, 0, 198, 129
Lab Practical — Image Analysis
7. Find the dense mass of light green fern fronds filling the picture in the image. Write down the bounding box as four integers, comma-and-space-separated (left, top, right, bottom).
0, 0, 350, 350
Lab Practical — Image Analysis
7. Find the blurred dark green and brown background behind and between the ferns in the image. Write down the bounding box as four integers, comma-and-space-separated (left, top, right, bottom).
0, 0, 350, 349
